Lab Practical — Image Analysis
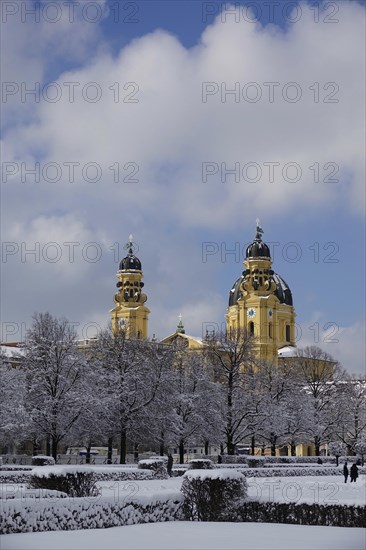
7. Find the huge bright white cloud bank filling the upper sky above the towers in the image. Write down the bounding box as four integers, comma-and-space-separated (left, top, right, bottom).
3, 3, 365, 227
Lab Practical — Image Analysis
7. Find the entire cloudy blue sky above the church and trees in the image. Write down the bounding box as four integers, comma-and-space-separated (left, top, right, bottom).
1, 0, 365, 373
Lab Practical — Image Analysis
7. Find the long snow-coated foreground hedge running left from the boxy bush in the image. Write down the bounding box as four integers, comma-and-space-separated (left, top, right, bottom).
0, 497, 183, 534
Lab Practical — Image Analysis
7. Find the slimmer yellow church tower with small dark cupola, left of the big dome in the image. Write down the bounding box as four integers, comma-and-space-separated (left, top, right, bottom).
110, 235, 150, 339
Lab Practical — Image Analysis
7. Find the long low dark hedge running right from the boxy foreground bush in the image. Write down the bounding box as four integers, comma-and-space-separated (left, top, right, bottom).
239, 501, 366, 527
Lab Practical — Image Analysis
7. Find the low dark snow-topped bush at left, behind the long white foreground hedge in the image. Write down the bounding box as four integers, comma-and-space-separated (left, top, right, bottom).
29, 466, 99, 497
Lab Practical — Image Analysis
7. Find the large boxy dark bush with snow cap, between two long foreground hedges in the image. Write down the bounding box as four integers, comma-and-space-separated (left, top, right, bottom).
181, 469, 247, 521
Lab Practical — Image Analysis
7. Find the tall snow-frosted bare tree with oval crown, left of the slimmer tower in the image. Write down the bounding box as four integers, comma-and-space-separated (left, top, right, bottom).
22, 313, 84, 460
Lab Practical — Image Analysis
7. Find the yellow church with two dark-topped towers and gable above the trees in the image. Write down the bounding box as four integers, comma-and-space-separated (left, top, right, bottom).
111, 220, 296, 364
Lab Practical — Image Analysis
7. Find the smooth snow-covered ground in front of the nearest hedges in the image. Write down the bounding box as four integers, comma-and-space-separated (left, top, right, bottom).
1, 521, 366, 550
